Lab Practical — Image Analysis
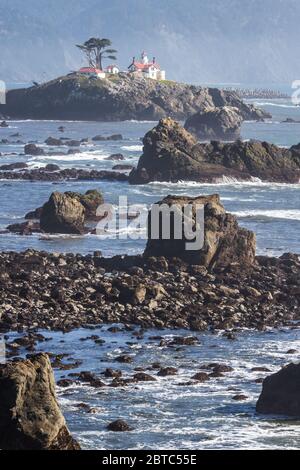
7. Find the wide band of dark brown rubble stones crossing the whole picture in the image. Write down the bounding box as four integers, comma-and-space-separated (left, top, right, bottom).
0, 250, 300, 330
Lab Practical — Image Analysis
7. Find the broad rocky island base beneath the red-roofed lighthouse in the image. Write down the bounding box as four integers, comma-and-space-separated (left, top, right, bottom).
5, 74, 266, 121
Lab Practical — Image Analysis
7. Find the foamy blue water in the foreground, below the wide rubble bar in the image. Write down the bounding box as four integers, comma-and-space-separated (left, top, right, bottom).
5, 326, 300, 450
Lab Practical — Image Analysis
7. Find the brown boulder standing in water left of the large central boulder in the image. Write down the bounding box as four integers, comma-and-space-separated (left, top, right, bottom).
40, 192, 85, 234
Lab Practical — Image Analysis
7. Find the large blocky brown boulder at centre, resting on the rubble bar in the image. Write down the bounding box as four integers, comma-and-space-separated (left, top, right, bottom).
144, 194, 256, 269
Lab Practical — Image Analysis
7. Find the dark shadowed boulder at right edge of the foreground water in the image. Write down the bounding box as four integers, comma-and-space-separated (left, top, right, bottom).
256, 364, 300, 417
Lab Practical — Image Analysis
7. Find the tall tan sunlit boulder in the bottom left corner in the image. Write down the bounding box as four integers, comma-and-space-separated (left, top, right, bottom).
0, 354, 80, 450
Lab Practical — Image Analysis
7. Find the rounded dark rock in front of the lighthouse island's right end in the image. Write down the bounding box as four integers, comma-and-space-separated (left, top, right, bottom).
184, 106, 243, 140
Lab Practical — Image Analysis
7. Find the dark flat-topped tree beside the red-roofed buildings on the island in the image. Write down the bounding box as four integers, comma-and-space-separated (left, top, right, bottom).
76, 38, 117, 70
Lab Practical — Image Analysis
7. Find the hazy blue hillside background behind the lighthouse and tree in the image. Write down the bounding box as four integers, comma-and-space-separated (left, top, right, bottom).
0, 0, 300, 83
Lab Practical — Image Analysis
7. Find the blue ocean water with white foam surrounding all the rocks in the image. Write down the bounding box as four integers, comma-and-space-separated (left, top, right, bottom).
0, 100, 300, 449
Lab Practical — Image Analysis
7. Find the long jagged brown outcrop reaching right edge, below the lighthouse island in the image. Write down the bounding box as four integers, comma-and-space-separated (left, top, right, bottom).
129, 118, 300, 184
